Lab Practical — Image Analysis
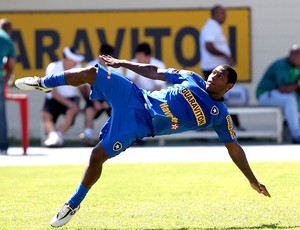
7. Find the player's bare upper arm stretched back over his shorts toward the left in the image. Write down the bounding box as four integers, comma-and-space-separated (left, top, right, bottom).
99, 55, 166, 81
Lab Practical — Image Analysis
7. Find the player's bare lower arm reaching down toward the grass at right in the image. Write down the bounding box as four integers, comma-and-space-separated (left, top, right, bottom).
225, 142, 271, 197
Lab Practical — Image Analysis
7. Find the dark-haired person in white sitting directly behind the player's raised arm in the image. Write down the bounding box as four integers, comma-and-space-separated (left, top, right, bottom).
125, 42, 166, 92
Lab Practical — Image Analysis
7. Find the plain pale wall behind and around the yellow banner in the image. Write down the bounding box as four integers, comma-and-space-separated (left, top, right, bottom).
0, 0, 300, 138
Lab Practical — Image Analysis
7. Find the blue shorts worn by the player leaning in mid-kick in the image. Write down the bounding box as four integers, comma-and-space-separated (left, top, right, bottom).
90, 65, 153, 158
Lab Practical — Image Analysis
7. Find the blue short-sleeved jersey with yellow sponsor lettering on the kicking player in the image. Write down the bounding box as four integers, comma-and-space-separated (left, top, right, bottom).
144, 69, 236, 143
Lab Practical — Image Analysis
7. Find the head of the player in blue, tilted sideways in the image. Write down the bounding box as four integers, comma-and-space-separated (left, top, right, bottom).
206, 64, 237, 99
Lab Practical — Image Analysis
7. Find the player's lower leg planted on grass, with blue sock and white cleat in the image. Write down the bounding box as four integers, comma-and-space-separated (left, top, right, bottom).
50, 143, 109, 227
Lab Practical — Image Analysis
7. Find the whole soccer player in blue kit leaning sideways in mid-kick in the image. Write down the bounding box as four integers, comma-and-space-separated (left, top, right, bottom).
15, 55, 270, 227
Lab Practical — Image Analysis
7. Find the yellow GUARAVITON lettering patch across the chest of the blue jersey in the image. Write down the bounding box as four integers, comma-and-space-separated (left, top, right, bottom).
181, 88, 206, 126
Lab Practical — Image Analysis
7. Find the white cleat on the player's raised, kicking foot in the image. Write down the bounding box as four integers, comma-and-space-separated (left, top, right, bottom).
15, 77, 52, 93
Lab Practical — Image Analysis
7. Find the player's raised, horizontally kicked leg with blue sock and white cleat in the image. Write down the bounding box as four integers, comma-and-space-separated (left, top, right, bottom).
15, 66, 98, 93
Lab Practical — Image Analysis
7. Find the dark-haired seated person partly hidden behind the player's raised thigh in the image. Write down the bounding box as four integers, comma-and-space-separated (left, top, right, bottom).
79, 44, 123, 146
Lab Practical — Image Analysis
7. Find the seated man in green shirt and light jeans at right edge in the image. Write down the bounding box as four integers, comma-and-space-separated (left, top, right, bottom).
256, 44, 300, 144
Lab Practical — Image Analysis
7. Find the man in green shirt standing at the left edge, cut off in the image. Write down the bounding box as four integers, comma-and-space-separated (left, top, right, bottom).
0, 18, 16, 155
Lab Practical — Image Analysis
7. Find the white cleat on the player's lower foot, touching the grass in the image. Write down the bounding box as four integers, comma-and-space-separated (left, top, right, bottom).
50, 203, 80, 227
